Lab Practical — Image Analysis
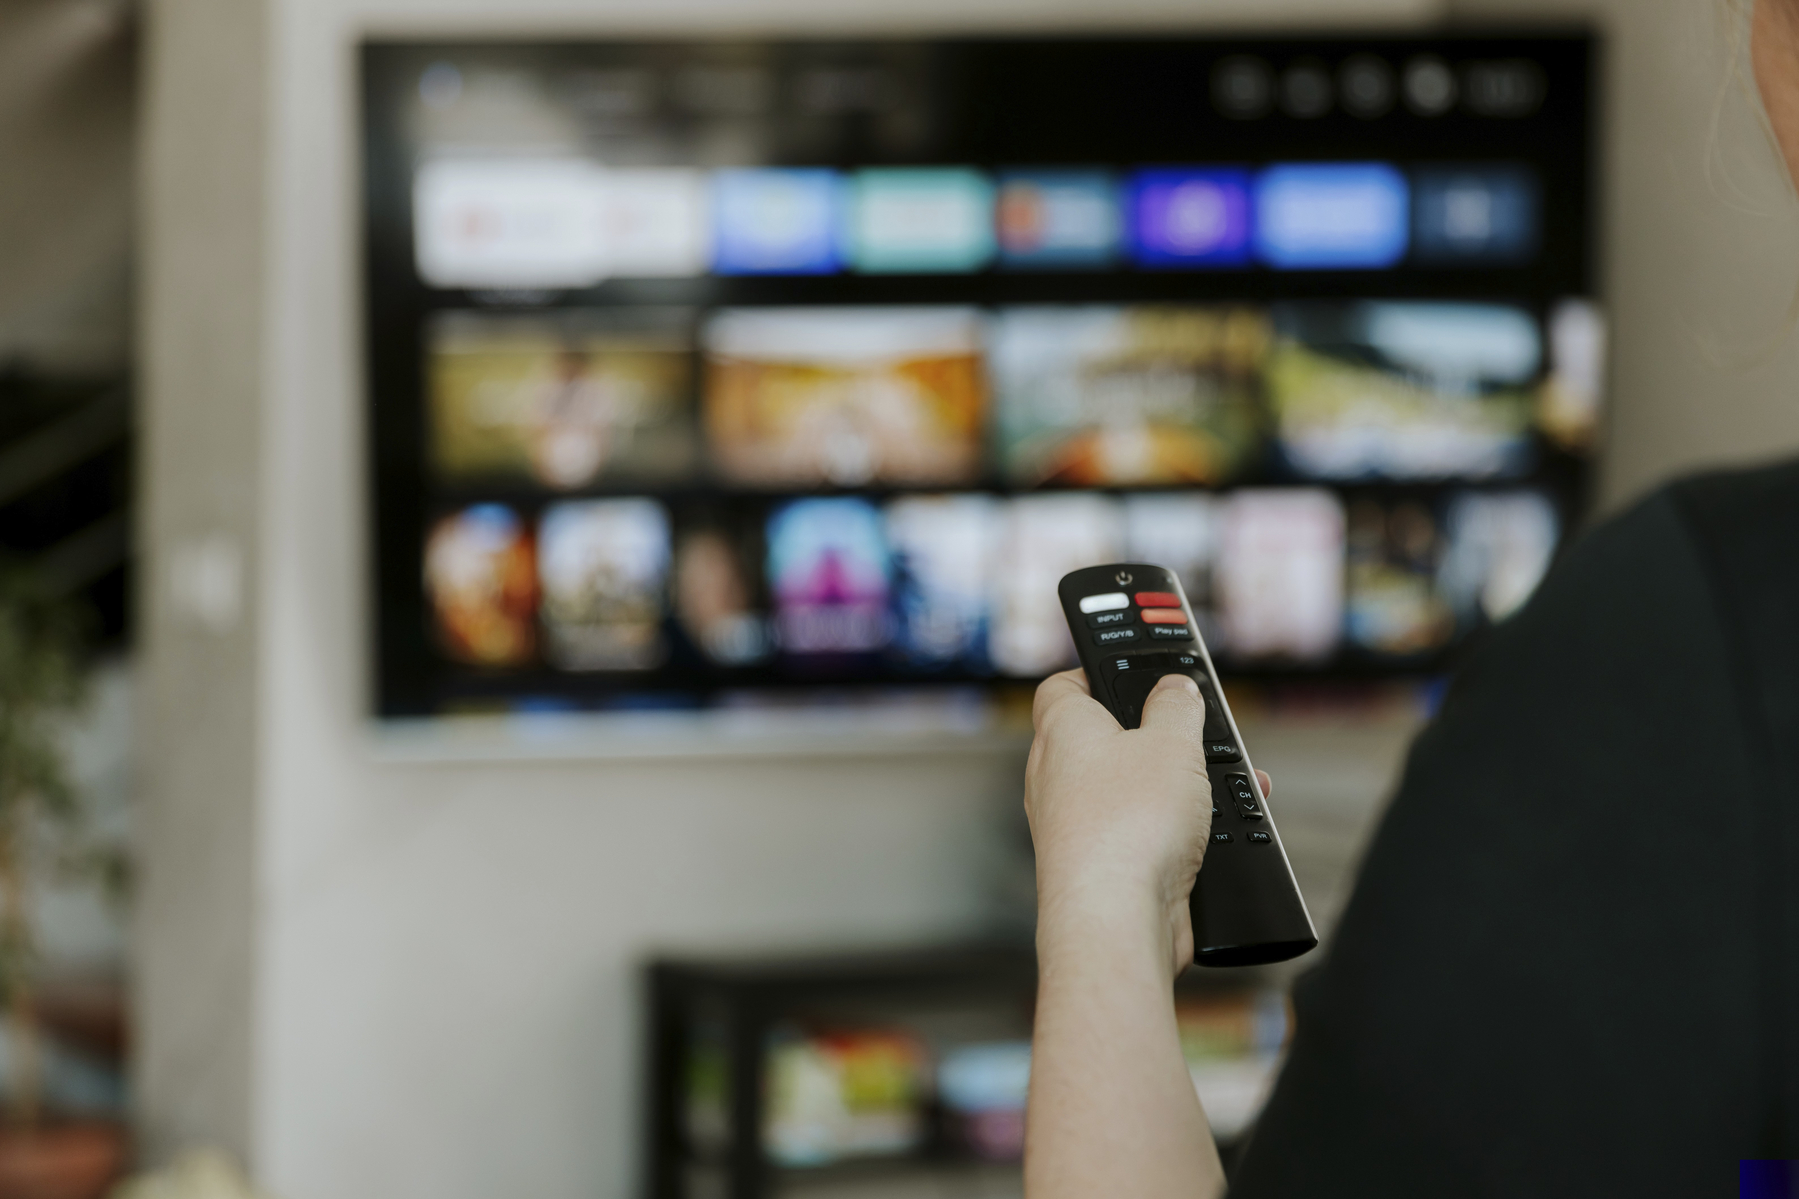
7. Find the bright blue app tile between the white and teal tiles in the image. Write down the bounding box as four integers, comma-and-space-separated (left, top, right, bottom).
712, 169, 844, 275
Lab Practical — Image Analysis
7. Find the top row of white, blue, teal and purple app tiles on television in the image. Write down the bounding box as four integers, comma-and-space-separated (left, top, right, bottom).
414, 158, 1540, 288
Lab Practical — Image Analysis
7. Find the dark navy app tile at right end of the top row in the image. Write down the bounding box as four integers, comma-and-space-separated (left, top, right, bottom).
1412, 164, 1538, 265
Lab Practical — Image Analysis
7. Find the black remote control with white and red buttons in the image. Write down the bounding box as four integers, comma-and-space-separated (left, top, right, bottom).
1056, 562, 1319, 967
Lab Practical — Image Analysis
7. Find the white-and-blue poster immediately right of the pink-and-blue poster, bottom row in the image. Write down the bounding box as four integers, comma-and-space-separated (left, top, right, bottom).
885, 495, 998, 670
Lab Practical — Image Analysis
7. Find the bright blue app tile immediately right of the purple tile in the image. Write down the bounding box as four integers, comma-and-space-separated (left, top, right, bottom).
1256, 162, 1410, 270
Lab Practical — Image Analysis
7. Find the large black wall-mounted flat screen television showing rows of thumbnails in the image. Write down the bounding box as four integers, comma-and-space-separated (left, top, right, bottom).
362, 34, 1605, 717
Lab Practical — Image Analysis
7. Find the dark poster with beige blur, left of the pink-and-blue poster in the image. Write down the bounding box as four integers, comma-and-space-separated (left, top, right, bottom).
675, 517, 772, 666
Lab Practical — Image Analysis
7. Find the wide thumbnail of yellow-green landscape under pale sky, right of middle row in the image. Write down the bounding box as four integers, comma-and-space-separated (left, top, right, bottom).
1266, 302, 1542, 479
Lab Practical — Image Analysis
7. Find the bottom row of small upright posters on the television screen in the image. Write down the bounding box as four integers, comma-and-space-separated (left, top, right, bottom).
423, 488, 1560, 677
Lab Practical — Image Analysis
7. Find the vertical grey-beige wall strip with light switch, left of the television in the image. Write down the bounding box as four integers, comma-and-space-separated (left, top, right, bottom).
133, 0, 268, 1154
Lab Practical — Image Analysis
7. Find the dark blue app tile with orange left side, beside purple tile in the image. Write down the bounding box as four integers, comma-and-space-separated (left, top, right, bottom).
998, 171, 1123, 270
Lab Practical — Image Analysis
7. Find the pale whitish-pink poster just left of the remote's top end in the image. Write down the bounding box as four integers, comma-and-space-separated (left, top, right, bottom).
988, 493, 1124, 679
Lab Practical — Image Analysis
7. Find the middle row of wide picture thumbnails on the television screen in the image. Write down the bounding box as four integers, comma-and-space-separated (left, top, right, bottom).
426, 301, 1605, 493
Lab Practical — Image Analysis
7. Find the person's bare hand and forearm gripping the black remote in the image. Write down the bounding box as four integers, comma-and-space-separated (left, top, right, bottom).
1024, 670, 1266, 1195
